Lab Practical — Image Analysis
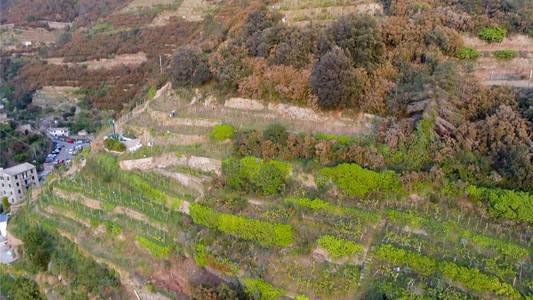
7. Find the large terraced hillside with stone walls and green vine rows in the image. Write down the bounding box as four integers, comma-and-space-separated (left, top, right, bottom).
10, 86, 533, 299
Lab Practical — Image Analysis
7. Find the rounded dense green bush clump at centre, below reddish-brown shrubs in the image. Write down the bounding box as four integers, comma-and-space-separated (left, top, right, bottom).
222, 156, 290, 195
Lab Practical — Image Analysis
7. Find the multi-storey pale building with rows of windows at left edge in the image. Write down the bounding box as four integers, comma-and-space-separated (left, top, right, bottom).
0, 163, 39, 203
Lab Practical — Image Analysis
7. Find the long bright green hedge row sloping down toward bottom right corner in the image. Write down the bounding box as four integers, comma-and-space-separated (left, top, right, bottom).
375, 245, 521, 299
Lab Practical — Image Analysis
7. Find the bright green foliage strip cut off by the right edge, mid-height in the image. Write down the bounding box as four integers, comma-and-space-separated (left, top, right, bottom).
466, 185, 533, 223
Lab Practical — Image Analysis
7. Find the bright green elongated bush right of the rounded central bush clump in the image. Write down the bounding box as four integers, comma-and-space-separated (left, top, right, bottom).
317, 164, 403, 197
